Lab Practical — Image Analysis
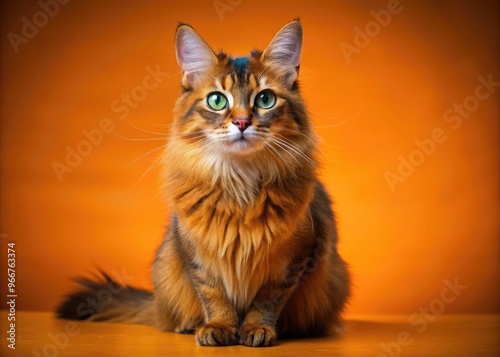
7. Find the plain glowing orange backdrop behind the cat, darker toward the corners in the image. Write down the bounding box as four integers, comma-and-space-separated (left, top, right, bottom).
0, 0, 500, 315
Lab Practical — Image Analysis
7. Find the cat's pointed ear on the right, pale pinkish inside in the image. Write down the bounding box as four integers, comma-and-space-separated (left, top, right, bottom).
262, 19, 302, 86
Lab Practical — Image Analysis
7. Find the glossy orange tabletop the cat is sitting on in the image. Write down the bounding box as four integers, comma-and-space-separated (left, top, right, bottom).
0, 311, 500, 357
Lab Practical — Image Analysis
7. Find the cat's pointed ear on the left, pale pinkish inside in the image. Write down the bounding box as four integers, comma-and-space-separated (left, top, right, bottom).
175, 24, 217, 86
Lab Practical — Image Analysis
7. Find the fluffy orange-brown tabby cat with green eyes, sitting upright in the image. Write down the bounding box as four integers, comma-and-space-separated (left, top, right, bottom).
57, 19, 350, 347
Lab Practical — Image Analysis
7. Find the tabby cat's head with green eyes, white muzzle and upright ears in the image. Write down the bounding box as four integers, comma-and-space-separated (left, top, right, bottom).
173, 19, 313, 170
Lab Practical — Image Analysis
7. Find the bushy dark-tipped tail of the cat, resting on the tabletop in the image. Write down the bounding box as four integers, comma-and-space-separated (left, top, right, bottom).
56, 272, 154, 326
